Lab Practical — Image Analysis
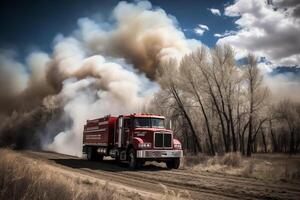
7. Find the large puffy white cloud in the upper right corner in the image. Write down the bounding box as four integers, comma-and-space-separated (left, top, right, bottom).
215, 0, 300, 65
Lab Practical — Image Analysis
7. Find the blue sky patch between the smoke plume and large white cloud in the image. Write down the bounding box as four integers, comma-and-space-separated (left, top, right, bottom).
145, 0, 236, 47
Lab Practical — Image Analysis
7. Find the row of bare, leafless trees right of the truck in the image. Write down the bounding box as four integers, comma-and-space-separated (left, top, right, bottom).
149, 46, 300, 156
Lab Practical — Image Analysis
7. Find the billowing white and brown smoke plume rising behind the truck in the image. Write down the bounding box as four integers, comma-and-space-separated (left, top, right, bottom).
0, 1, 199, 155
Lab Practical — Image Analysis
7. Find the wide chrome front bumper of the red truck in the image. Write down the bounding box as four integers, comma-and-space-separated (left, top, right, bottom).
136, 150, 183, 158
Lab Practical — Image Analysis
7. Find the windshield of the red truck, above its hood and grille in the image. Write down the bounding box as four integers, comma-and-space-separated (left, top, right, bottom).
134, 117, 165, 128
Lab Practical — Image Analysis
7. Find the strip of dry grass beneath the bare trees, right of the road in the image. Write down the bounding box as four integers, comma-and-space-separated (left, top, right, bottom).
185, 153, 300, 182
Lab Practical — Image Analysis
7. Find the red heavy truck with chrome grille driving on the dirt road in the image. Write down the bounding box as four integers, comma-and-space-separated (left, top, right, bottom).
83, 114, 183, 169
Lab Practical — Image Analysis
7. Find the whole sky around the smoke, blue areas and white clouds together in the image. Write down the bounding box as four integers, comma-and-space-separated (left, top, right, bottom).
0, 0, 300, 68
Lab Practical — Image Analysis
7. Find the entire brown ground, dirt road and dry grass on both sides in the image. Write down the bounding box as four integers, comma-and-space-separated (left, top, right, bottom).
0, 150, 300, 200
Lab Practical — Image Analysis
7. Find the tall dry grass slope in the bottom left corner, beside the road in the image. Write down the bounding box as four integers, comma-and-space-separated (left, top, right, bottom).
0, 150, 120, 200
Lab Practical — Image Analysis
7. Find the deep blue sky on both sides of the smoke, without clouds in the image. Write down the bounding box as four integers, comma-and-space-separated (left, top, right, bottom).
0, 0, 236, 53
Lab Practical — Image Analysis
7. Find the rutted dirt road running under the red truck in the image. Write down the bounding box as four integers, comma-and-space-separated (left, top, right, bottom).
23, 151, 300, 200
